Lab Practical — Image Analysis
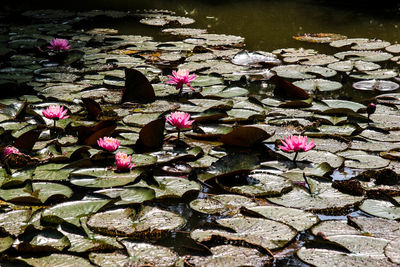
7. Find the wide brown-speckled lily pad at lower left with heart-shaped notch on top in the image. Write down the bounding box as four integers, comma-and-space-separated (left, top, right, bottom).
87, 207, 185, 237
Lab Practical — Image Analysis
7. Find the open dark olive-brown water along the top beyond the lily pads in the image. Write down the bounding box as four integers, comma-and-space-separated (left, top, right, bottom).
3, 0, 400, 52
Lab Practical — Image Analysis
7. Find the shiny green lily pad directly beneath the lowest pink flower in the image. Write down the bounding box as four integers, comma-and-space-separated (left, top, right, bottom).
70, 168, 142, 188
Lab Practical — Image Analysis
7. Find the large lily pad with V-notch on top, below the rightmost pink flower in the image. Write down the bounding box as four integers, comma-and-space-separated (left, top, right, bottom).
268, 178, 364, 213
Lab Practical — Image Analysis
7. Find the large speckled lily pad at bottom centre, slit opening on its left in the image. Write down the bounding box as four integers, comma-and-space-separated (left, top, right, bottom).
190, 217, 296, 250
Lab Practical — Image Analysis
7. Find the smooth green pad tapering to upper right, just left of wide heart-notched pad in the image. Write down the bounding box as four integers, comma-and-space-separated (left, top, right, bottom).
42, 199, 110, 227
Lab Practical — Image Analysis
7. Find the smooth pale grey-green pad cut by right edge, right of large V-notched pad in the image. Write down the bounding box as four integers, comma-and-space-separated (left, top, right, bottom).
360, 199, 400, 220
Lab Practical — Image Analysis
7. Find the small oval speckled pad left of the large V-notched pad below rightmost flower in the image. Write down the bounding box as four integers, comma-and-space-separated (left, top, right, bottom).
190, 195, 257, 215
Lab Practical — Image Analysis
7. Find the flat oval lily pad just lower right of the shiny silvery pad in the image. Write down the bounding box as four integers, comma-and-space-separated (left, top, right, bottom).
271, 65, 336, 79
